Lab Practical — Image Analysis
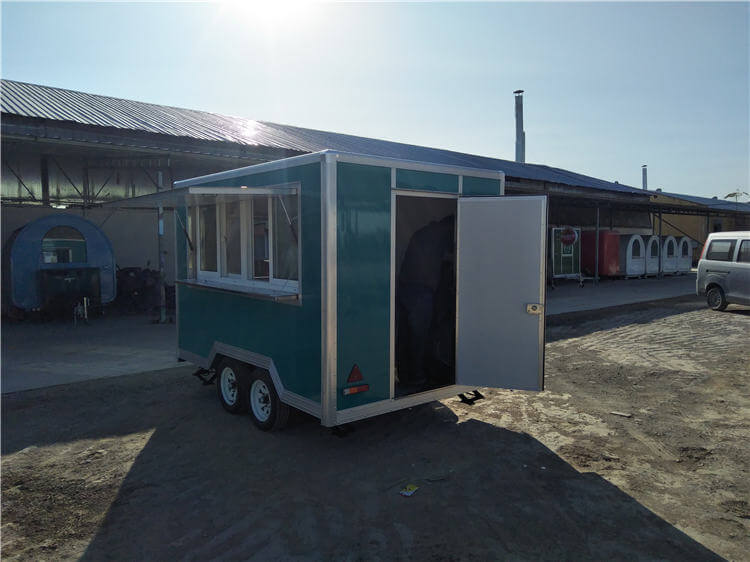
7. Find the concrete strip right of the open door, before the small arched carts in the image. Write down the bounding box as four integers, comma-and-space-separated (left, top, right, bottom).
546, 273, 697, 316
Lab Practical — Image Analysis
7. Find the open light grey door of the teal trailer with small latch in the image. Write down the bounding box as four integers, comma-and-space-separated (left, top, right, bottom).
456, 197, 547, 390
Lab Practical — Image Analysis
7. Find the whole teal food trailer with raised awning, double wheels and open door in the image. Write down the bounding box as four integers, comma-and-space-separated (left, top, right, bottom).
122, 151, 547, 429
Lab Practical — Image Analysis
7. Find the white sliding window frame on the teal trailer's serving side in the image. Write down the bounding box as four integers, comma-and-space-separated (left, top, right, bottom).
188, 183, 302, 295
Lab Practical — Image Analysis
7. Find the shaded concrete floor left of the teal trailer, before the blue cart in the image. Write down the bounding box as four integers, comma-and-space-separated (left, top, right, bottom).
0, 315, 185, 393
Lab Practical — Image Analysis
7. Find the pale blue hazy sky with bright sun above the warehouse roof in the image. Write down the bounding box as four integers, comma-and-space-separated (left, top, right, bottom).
0, 1, 750, 200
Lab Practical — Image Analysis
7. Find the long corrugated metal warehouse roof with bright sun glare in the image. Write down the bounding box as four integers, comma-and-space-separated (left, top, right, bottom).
1, 79, 704, 195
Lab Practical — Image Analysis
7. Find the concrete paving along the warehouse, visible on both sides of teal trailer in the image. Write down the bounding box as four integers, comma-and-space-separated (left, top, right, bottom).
0, 273, 697, 393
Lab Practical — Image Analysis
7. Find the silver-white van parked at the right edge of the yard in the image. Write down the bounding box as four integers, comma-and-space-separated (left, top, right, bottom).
695, 231, 750, 310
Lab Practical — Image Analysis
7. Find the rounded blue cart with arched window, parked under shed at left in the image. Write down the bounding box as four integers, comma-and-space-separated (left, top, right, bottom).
3, 214, 116, 311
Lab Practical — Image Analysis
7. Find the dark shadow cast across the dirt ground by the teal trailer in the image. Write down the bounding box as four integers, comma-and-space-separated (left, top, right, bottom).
3, 372, 719, 560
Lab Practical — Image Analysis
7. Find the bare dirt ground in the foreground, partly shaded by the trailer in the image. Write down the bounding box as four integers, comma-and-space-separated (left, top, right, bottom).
2, 299, 750, 560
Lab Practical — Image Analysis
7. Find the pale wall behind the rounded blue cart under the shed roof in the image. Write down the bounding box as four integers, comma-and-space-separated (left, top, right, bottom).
2, 205, 175, 284
